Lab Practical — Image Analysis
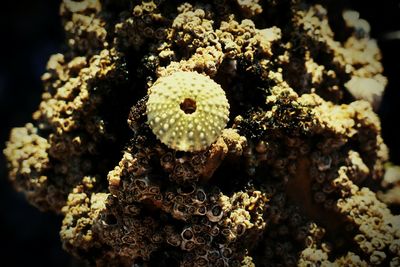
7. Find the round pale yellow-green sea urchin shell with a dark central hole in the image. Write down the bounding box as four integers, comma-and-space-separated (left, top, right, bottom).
147, 71, 229, 151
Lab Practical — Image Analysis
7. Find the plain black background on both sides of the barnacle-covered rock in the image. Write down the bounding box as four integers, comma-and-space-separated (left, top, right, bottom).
0, 0, 400, 267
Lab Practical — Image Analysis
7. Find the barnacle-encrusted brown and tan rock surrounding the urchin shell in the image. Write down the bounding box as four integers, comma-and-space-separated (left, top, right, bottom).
4, 0, 400, 266
